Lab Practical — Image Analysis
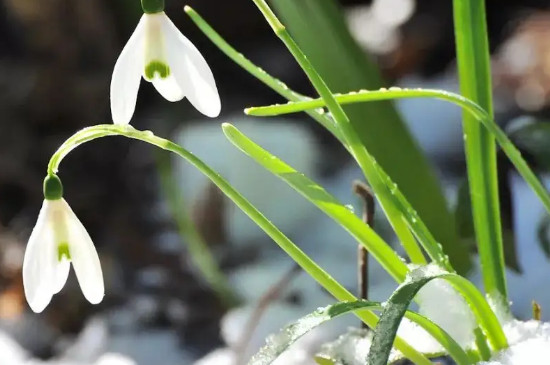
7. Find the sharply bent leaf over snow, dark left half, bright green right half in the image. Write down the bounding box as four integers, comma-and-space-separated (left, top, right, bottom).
367, 267, 508, 365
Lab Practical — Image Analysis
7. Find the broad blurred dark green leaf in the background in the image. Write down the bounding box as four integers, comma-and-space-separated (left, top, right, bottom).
270, 0, 470, 273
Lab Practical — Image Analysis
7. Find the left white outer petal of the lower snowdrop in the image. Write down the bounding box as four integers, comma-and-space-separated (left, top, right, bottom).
23, 200, 55, 313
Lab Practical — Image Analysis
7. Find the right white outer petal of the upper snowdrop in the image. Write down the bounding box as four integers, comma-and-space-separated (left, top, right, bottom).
162, 14, 221, 118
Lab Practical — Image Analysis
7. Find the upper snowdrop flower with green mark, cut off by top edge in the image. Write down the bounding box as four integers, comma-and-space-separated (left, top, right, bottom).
111, 0, 221, 124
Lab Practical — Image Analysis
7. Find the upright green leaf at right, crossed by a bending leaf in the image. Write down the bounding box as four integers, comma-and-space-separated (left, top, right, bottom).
453, 0, 509, 311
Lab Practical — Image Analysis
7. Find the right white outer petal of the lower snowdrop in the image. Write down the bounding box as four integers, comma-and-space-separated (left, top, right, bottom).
63, 200, 105, 304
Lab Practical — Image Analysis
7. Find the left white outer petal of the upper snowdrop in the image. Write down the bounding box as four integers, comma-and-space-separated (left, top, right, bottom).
111, 15, 145, 124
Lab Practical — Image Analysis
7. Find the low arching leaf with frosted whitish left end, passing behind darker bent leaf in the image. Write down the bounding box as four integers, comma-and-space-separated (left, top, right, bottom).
248, 300, 470, 365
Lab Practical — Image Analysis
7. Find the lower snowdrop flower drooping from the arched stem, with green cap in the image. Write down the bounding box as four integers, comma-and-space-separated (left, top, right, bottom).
23, 175, 105, 313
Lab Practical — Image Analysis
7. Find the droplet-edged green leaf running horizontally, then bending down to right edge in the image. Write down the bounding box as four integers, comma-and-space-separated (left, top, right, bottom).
246, 88, 550, 232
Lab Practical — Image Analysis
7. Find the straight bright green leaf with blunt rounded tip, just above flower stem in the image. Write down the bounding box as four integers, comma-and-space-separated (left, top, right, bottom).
222, 123, 408, 282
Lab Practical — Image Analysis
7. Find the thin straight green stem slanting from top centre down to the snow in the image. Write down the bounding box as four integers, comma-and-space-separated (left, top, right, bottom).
249, 0, 426, 265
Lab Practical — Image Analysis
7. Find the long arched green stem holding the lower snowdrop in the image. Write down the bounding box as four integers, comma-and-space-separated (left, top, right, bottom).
48, 124, 431, 365
